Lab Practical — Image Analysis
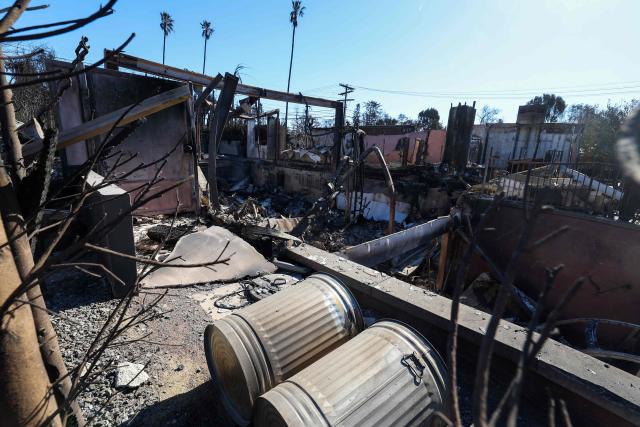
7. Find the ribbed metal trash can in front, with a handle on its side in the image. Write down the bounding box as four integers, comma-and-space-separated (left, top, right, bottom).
253, 320, 450, 427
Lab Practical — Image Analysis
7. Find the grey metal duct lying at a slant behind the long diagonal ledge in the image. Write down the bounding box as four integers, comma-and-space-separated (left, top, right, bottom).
339, 216, 452, 267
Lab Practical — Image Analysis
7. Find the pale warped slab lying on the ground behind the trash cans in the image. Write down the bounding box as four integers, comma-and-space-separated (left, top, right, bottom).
142, 226, 276, 288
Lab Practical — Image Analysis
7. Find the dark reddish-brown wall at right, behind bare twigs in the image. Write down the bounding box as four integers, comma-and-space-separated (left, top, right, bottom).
478, 205, 640, 349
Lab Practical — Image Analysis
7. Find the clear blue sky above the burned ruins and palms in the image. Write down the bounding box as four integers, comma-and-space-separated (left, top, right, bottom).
12, 0, 640, 122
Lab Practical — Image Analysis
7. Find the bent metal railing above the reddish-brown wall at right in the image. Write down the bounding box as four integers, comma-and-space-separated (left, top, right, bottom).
490, 161, 625, 219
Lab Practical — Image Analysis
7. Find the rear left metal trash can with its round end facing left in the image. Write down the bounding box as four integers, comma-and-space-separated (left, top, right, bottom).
204, 274, 363, 426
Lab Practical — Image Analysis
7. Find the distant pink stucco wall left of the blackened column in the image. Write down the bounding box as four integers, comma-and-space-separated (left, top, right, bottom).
364, 130, 447, 166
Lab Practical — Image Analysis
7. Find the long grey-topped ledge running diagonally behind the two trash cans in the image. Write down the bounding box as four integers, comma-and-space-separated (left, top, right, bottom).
285, 244, 640, 425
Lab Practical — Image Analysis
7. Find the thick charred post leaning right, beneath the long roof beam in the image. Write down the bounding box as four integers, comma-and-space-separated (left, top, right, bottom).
207, 73, 239, 210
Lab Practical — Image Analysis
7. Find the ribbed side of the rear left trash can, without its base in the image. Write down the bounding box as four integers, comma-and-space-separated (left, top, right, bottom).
236, 274, 363, 383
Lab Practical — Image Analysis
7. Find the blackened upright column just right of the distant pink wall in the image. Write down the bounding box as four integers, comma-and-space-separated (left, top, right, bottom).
442, 103, 476, 174
